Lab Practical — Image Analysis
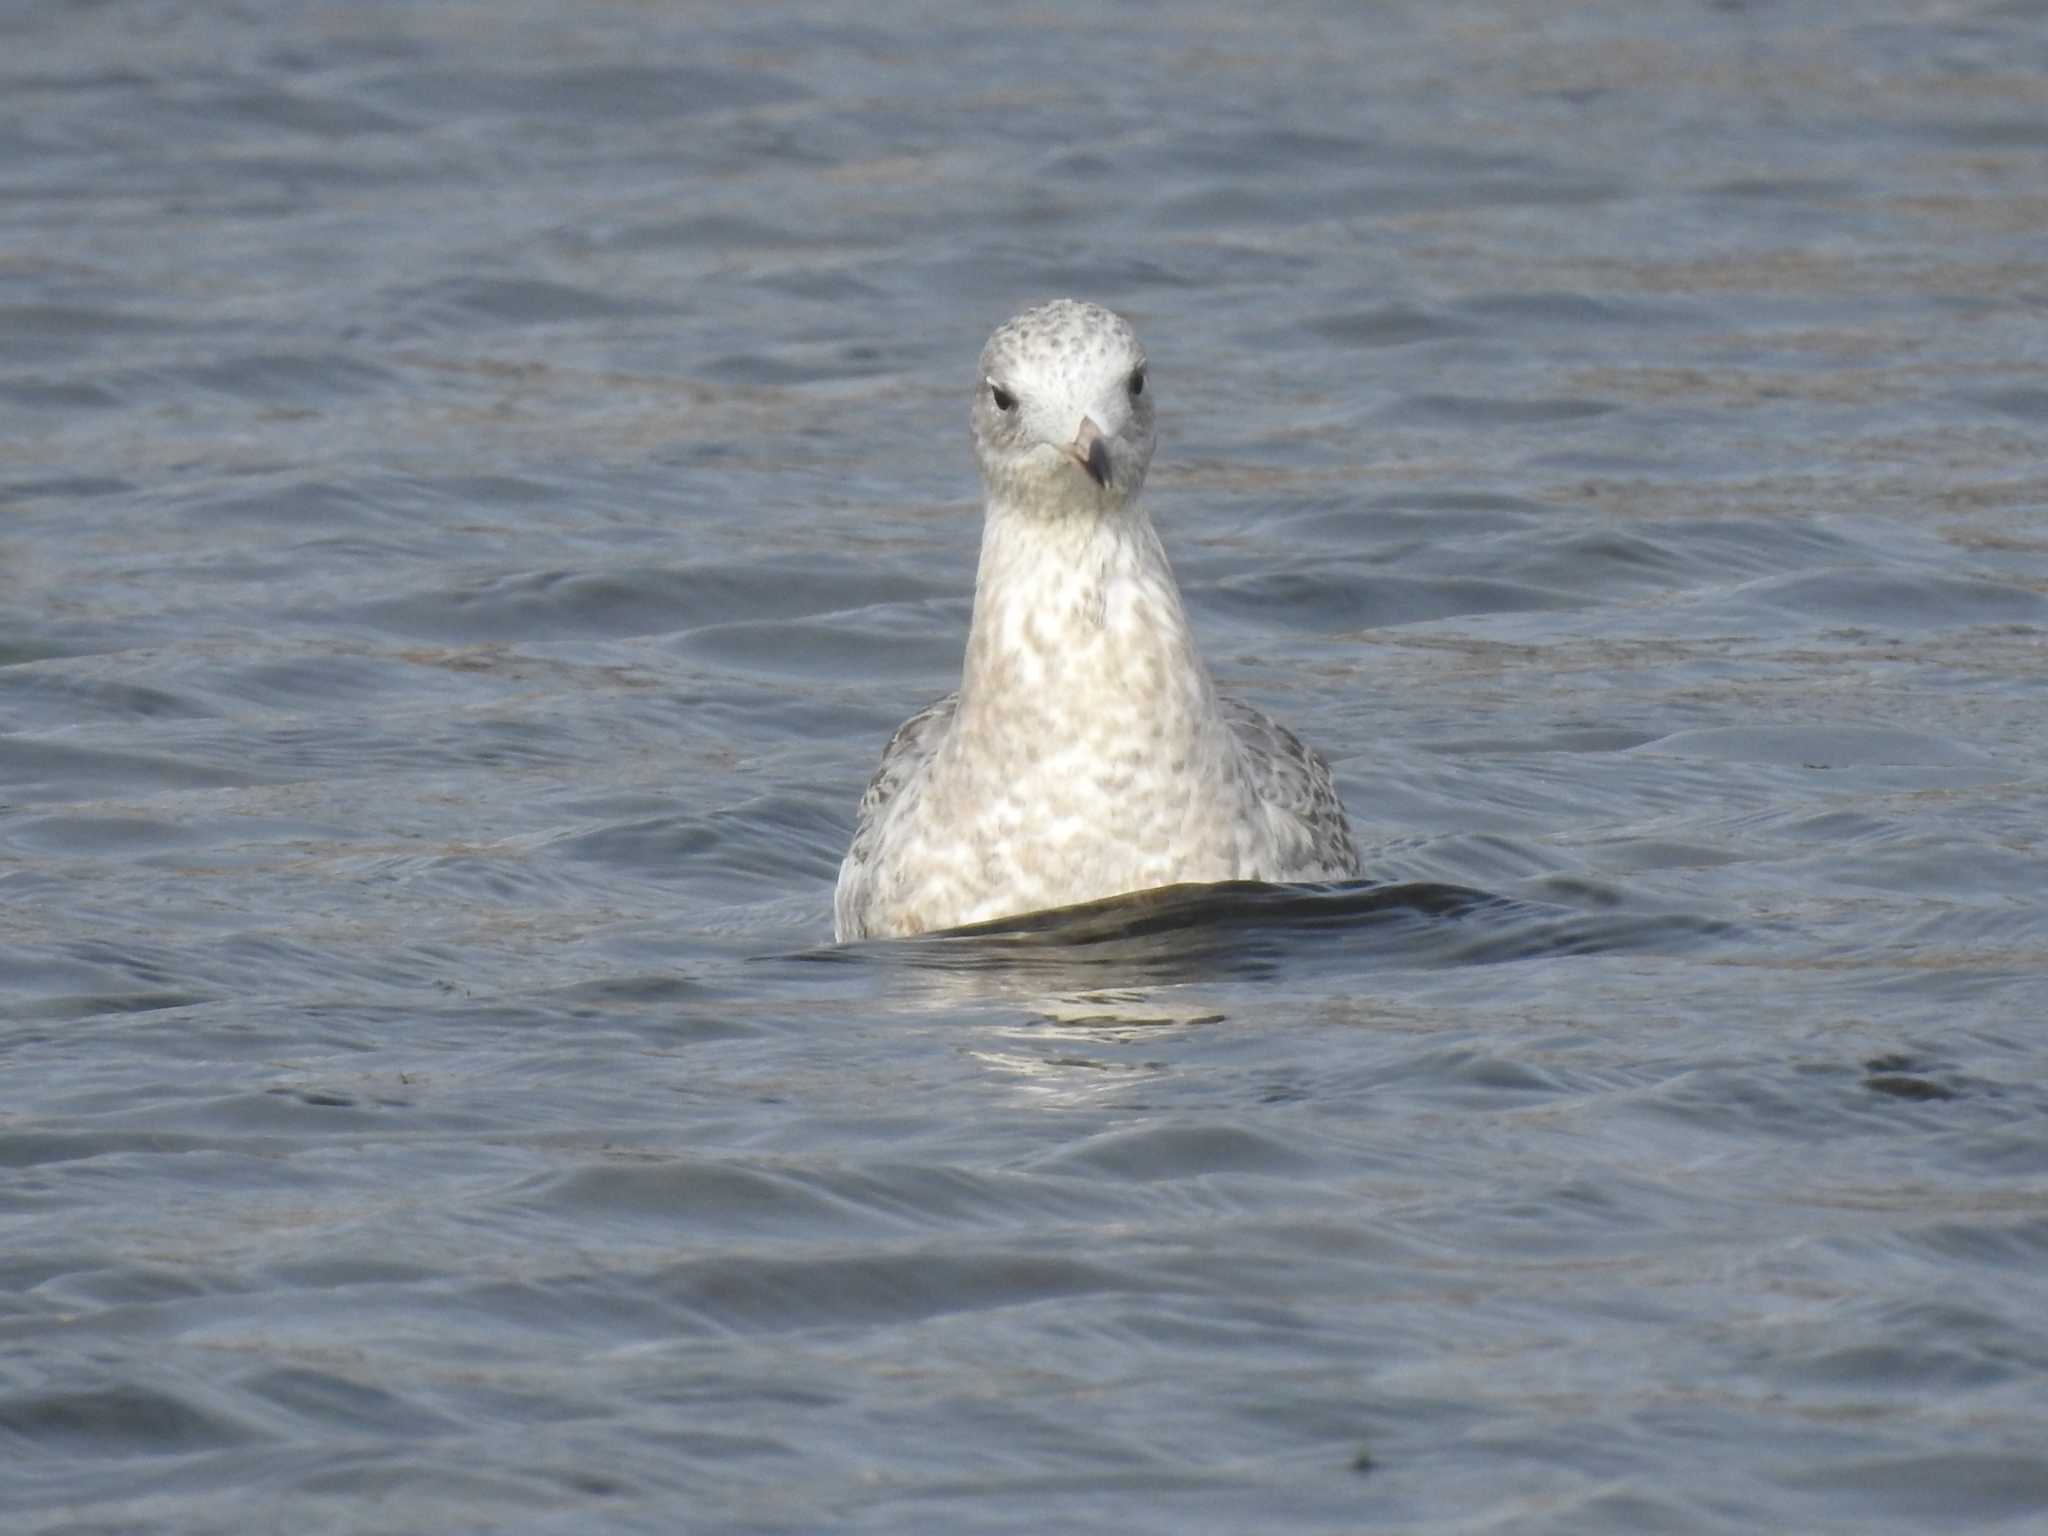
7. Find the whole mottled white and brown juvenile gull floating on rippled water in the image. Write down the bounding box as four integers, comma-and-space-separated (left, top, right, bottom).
834, 299, 1358, 940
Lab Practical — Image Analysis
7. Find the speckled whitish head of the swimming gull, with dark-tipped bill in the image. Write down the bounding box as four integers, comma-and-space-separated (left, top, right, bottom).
973, 299, 1153, 516
